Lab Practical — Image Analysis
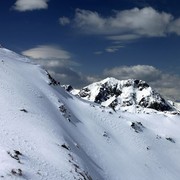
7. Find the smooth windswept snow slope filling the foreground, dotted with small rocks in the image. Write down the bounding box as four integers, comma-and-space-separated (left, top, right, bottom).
0, 48, 180, 180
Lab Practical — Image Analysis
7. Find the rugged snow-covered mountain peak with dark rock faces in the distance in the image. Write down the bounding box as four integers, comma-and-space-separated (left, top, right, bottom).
71, 77, 179, 113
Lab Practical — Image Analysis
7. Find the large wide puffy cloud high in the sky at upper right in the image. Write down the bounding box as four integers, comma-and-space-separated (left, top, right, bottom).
74, 7, 173, 37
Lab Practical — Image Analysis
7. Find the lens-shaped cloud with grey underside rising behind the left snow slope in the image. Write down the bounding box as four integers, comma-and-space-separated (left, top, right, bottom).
22, 45, 89, 87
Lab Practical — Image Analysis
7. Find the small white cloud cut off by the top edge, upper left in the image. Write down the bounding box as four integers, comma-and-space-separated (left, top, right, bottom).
13, 0, 49, 12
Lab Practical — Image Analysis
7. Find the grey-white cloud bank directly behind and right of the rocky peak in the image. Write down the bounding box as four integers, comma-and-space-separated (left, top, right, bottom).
103, 65, 180, 100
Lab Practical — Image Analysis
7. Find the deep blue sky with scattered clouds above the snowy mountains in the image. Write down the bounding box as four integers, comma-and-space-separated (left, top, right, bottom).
0, 0, 180, 100
